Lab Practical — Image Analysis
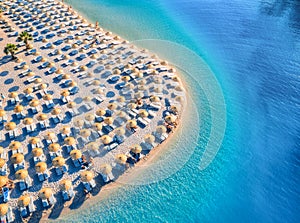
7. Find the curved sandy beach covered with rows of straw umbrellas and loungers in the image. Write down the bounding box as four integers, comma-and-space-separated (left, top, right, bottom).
0, 0, 186, 221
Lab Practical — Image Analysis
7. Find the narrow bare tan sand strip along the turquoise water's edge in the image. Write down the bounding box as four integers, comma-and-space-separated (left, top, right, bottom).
0, 0, 187, 220
